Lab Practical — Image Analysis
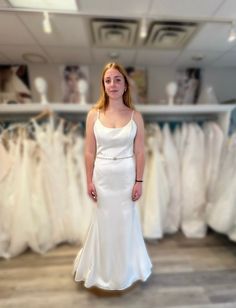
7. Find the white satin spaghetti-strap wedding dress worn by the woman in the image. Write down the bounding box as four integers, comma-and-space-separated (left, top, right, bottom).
73, 112, 152, 290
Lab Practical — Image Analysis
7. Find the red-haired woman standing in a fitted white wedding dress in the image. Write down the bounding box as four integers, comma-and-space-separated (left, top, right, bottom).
74, 63, 152, 290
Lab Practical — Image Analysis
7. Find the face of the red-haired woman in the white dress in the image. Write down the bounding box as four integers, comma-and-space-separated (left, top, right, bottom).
103, 68, 125, 99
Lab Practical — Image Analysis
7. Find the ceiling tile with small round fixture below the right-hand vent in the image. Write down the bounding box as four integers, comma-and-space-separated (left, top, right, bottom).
175, 50, 222, 67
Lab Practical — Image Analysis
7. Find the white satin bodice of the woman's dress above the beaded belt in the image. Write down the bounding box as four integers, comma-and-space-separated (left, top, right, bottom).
94, 113, 137, 158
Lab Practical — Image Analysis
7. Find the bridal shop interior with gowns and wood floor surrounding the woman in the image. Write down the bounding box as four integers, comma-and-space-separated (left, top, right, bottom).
0, 0, 236, 308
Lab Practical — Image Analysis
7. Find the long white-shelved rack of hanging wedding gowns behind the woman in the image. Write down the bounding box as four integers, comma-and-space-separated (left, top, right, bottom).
0, 104, 236, 258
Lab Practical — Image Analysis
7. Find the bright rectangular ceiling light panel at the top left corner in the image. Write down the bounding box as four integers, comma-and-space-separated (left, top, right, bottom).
8, 0, 78, 11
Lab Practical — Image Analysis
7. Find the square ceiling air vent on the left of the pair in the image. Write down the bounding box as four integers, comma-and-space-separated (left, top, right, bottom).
92, 19, 138, 48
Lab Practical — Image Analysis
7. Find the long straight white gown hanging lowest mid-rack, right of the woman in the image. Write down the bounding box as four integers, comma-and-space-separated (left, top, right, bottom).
181, 124, 206, 238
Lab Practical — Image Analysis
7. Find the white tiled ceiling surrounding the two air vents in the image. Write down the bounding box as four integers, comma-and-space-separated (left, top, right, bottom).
0, 0, 236, 68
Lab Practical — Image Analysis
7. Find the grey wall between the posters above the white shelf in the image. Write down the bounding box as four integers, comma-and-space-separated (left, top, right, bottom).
29, 64, 236, 104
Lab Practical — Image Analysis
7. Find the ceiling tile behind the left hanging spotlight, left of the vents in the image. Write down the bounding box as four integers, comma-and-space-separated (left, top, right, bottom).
20, 13, 90, 47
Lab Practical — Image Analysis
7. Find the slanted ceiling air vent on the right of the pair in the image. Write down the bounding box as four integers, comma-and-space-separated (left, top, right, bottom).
146, 21, 197, 49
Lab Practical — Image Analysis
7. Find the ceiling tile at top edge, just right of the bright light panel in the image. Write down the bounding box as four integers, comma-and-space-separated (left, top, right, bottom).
78, 0, 151, 16
